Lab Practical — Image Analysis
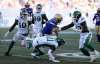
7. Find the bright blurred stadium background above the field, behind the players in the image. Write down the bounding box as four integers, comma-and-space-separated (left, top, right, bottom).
0, 0, 100, 28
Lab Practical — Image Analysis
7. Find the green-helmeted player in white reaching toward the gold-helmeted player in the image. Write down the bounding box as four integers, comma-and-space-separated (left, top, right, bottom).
61, 11, 97, 62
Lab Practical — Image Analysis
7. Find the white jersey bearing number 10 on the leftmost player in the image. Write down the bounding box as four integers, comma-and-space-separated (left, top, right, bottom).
16, 17, 28, 34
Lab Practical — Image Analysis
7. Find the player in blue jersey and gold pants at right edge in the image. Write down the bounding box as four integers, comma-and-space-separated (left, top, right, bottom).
93, 8, 100, 42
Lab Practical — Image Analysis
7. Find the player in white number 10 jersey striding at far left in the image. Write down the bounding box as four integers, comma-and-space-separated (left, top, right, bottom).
5, 10, 31, 56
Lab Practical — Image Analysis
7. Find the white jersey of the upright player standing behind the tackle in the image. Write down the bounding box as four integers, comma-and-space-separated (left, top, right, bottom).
33, 12, 43, 28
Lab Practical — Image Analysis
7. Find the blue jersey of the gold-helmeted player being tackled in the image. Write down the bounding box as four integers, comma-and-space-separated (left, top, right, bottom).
43, 18, 57, 35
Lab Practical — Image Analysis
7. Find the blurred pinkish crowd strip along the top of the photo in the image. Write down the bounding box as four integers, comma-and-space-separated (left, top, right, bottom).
0, 0, 100, 11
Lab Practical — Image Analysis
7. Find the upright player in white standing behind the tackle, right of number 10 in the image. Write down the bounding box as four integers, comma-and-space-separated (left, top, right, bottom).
33, 4, 48, 37
